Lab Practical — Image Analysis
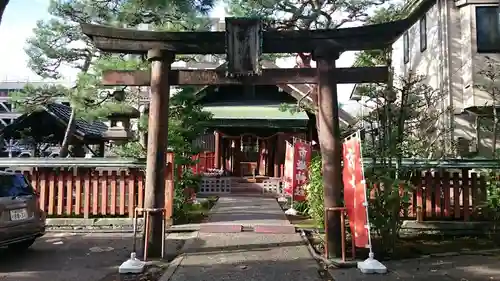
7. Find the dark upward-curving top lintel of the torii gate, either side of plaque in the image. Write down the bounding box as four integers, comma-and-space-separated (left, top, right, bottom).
81, 0, 435, 54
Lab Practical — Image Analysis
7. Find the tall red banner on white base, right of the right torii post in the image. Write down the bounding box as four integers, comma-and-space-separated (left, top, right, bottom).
342, 137, 370, 248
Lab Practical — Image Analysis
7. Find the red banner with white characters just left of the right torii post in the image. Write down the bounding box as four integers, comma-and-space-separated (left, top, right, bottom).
293, 141, 311, 201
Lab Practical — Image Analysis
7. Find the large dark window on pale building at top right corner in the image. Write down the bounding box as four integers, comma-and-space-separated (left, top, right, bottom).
476, 6, 500, 53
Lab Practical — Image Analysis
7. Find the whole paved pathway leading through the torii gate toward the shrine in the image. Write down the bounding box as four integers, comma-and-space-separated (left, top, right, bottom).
162, 196, 322, 281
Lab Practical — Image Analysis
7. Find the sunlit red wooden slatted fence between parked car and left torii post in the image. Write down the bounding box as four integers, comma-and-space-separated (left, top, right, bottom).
24, 169, 173, 218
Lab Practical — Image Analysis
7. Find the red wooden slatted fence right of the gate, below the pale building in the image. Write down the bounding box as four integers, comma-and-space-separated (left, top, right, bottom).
371, 168, 488, 221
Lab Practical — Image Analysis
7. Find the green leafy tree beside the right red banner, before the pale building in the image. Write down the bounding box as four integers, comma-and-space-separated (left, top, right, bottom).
355, 4, 452, 252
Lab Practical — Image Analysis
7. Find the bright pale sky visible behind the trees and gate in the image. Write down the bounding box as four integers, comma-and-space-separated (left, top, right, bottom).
0, 0, 360, 106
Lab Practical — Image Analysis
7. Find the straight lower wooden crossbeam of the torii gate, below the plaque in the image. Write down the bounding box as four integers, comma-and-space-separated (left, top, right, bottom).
102, 67, 389, 86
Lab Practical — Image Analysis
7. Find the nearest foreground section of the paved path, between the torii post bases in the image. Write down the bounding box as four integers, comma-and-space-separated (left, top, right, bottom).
170, 233, 323, 281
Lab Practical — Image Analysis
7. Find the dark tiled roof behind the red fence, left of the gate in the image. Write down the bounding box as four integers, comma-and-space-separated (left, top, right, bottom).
45, 103, 108, 138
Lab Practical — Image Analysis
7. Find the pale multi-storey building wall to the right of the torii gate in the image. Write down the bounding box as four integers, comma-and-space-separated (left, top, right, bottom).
392, 0, 500, 156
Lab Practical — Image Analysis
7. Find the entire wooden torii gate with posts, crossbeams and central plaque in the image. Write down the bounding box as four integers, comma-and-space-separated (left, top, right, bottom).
82, 18, 409, 257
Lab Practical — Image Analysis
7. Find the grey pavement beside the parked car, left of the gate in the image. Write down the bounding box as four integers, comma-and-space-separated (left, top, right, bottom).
0, 233, 189, 281
